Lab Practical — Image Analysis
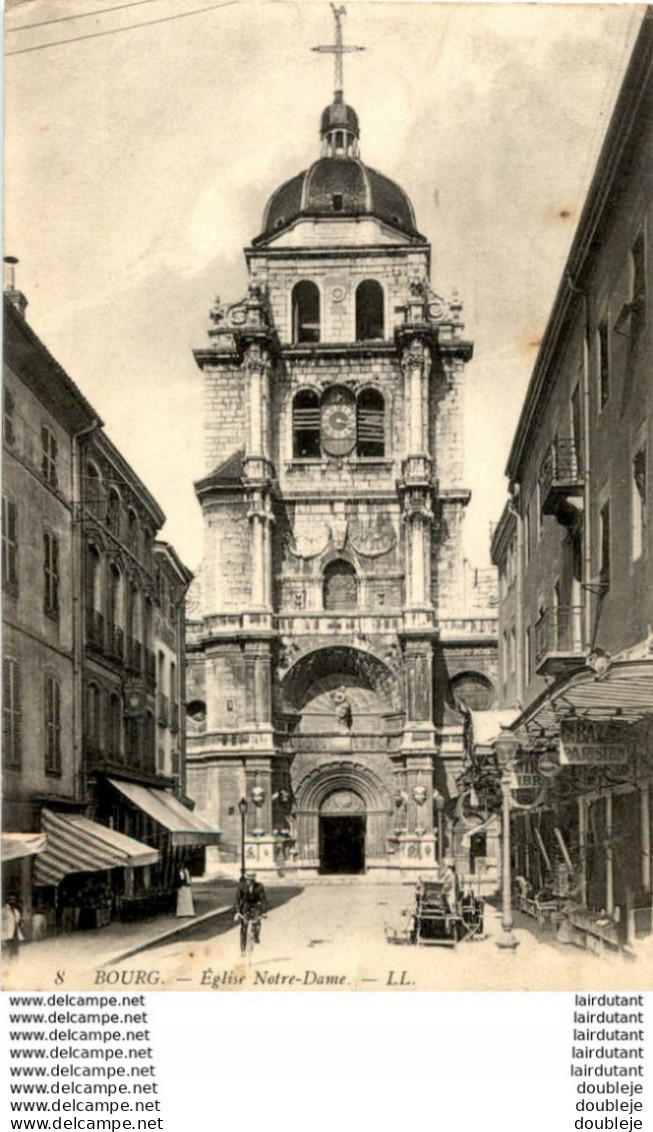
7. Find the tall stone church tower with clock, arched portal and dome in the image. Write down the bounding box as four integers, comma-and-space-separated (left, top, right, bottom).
187, 20, 497, 875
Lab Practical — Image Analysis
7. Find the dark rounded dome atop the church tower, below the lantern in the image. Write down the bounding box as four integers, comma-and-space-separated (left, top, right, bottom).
255, 156, 423, 243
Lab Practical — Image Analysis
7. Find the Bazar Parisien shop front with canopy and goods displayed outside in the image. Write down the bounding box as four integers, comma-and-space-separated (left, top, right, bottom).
513, 660, 653, 952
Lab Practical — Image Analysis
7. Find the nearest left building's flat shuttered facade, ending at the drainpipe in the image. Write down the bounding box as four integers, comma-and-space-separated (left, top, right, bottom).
2, 287, 96, 915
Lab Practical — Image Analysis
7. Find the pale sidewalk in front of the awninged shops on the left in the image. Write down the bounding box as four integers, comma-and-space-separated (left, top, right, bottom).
7, 877, 235, 970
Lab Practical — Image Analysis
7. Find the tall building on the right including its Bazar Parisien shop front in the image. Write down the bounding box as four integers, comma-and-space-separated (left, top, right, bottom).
492, 10, 653, 946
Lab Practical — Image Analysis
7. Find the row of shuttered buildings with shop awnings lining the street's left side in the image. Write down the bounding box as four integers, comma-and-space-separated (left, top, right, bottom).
2, 280, 211, 937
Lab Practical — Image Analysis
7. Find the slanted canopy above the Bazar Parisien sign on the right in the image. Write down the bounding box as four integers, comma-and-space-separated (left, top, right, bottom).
512, 659, 653, 743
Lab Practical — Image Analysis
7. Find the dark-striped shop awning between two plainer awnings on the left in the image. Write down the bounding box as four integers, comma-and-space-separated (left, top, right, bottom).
34, 809, 158, 884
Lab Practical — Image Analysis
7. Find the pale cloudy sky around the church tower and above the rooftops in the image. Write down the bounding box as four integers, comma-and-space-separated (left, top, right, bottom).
5, 0, 644, 568
